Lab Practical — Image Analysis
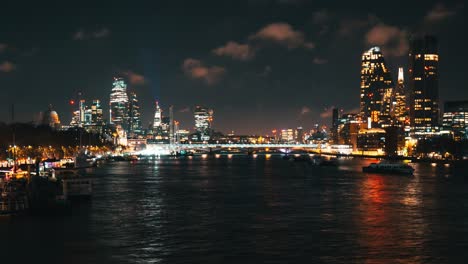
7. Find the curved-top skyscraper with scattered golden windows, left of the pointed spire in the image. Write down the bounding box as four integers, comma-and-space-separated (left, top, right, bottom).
360, 47, 393, 126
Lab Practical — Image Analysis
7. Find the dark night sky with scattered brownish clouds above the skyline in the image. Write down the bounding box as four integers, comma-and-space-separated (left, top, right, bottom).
0, 0, 468, 133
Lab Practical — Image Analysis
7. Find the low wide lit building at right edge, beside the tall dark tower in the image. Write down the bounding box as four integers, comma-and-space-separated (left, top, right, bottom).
442, 101, 468, 141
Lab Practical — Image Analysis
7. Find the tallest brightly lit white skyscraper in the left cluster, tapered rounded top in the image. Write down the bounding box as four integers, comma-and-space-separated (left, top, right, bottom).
109, 77, 129, 130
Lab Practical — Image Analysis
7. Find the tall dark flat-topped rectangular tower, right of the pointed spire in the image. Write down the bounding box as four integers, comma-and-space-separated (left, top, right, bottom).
409, 36, 439, 134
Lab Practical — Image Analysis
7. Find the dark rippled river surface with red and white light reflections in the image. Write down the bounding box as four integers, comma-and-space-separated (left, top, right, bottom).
0, 156, 468, 263
